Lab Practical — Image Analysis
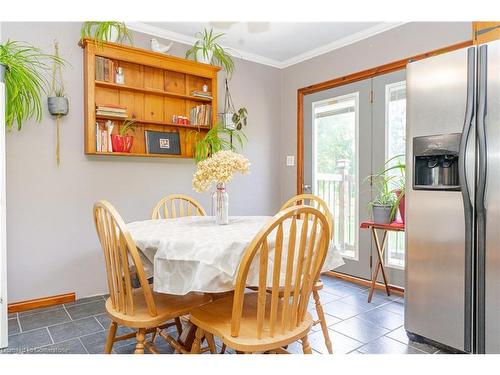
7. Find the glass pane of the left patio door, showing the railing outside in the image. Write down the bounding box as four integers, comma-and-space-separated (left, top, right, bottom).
313, 93, 359, 260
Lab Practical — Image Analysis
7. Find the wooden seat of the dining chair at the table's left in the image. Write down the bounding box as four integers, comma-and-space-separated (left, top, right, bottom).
106, 289, 212, 328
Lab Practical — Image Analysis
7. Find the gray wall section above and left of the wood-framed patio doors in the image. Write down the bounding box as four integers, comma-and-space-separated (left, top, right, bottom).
280, 22, 472, 201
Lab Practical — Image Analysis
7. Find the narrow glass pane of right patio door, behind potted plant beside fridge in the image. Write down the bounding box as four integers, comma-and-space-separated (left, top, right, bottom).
385, 81, 406, 269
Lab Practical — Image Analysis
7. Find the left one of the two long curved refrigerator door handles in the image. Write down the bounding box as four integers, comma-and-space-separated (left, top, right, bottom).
458, 47, 476, 352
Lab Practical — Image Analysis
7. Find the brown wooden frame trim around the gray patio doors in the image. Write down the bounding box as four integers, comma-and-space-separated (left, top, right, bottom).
297, 40, 473, 194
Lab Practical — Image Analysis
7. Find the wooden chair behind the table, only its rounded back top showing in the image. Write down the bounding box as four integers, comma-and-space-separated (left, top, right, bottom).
151, 194, 207, 220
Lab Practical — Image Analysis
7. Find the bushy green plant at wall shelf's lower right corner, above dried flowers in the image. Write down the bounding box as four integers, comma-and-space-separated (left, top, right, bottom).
191, 124, 247, 163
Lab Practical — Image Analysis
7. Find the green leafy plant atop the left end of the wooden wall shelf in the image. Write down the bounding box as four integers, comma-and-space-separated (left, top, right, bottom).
80, 21, 133, 45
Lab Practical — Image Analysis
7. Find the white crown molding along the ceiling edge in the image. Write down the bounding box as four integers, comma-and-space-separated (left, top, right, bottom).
126, 22, 406, 69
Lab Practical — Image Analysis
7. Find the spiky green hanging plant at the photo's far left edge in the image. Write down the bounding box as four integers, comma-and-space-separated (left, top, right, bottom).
0, 40, 65, 130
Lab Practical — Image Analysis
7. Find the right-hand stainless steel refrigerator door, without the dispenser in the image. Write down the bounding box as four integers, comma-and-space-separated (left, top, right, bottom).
478, 41, 500, 353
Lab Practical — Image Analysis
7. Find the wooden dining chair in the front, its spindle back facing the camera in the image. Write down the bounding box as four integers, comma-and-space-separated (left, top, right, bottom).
190, 206, 329, 354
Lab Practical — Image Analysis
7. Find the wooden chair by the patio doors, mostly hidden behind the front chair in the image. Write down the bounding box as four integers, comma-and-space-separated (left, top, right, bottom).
281, 194, 333, 354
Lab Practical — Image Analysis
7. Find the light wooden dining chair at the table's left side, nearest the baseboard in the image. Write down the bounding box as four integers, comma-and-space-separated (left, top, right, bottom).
94, 201, 211, 354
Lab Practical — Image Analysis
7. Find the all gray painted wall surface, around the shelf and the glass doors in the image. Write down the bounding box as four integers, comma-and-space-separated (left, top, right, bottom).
2, 22, 471, 302
